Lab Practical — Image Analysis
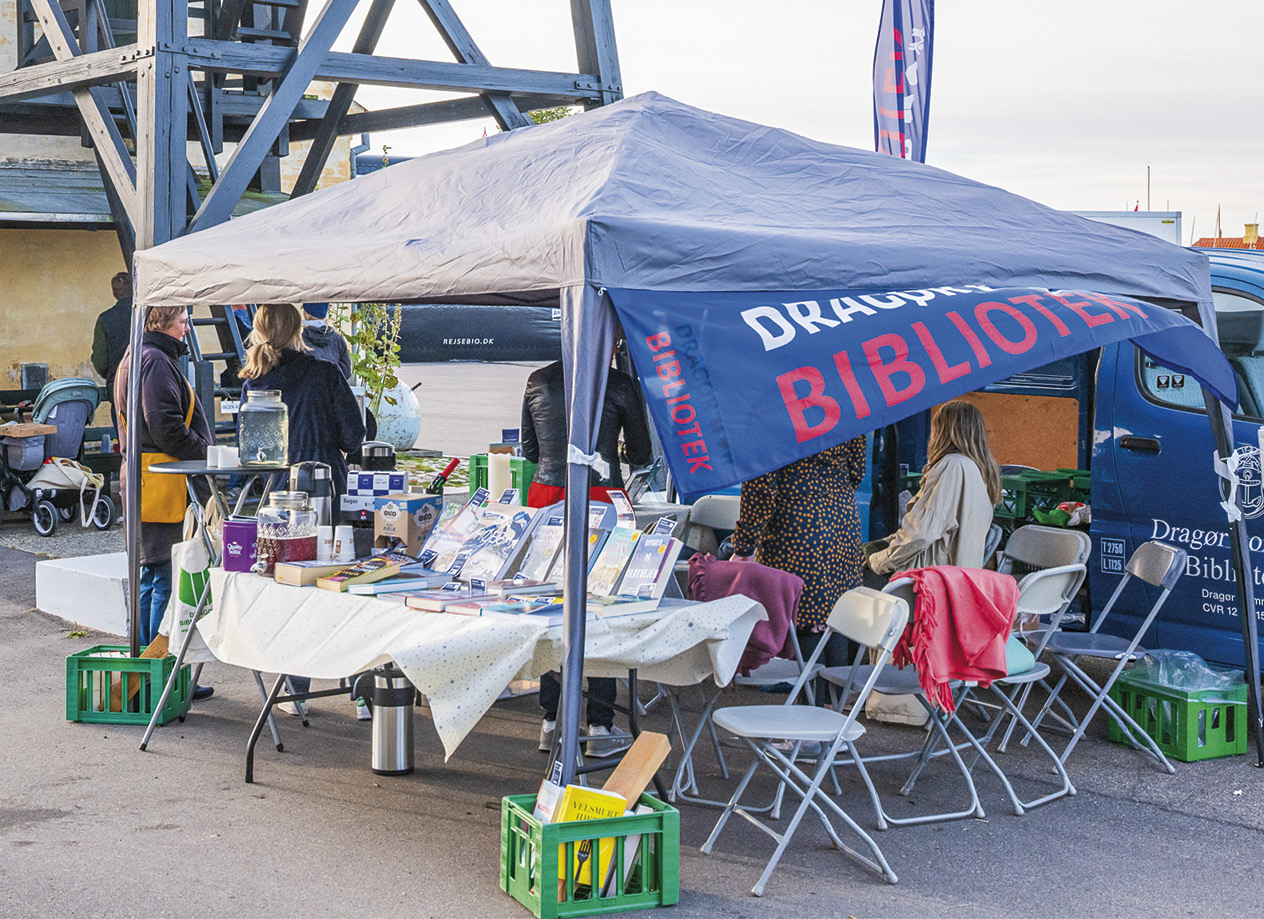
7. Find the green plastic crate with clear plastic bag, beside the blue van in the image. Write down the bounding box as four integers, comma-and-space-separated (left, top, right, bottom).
1106, 671, 1246, 762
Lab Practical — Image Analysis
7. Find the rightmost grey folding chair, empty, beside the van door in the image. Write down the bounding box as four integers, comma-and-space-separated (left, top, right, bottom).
1024, 540, 1186, 772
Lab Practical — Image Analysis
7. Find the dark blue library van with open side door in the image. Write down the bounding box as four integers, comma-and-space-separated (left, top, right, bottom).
858, 249, 1264, 666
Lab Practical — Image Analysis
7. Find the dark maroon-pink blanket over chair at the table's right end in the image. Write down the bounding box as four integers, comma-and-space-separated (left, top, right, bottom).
689, 554, 803, 676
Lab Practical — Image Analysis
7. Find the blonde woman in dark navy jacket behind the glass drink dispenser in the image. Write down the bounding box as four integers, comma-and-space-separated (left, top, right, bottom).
241, 303, 364, 508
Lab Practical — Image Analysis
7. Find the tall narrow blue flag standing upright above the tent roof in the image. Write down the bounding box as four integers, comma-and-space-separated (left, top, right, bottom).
873, 0, 935, 163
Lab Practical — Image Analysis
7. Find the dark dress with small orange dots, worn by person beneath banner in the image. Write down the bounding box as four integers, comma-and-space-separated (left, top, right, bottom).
733, 436, 865, 632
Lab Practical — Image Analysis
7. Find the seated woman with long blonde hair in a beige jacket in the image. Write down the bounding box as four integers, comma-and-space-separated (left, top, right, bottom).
866, 399, 1001, 574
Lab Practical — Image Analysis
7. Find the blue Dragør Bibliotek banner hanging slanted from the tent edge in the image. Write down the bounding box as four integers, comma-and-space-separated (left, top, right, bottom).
608, 284, 1237, 497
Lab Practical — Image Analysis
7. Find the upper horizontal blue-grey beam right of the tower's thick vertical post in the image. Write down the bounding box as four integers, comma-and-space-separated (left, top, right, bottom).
186, 38, 602, 102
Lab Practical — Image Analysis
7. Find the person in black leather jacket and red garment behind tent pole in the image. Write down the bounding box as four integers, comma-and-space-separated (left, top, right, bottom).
522, 343, 653, 757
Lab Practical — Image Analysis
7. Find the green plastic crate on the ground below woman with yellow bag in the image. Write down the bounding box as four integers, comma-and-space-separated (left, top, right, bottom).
66, 645, 191, 724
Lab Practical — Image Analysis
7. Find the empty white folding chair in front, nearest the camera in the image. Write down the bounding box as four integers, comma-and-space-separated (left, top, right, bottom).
702, 588, 909, 896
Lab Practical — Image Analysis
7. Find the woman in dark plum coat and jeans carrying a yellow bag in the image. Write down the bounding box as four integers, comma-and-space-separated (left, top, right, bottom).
114, 306, 215, 645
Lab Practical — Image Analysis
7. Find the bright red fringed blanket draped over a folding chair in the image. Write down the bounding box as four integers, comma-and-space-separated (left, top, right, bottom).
891, 565, 1019, 714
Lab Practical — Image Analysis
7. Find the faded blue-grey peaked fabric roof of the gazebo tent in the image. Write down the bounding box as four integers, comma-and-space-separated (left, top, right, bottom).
137, 92, 1211, 312
